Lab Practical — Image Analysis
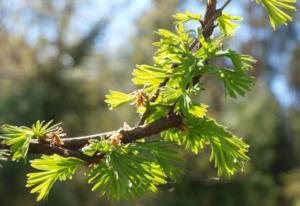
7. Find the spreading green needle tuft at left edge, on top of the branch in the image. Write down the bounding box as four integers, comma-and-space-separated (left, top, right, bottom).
1, 121, 60, 161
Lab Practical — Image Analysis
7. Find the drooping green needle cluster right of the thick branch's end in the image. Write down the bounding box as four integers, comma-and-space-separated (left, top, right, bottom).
162, 118, 249, 176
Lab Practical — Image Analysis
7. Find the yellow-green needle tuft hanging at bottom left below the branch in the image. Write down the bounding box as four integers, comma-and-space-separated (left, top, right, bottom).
26, 155, 83, 201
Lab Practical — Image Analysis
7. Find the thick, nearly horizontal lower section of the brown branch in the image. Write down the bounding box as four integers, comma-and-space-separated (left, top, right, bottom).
0, 114, 182, 163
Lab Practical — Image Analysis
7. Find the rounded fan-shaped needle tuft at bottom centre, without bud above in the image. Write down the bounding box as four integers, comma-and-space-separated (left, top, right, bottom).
88, 145, 166, 200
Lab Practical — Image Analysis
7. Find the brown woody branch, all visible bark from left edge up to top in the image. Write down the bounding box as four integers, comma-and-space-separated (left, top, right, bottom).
0, 0, 231, 163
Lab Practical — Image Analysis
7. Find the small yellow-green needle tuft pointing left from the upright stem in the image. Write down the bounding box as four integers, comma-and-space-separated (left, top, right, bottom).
105, 90, 134, 110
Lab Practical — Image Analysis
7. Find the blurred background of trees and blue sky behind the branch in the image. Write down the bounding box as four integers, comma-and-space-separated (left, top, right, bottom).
0, 0, 300, 206
